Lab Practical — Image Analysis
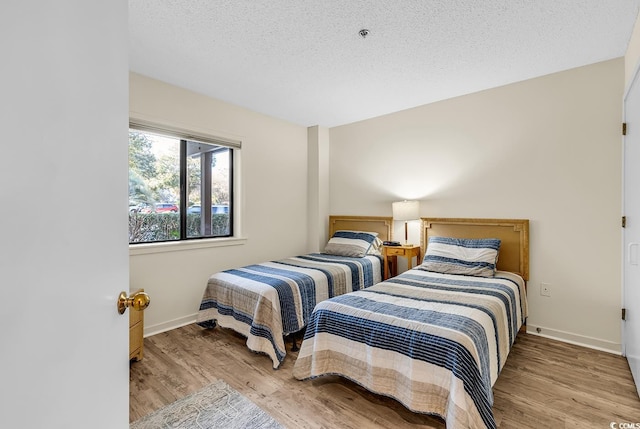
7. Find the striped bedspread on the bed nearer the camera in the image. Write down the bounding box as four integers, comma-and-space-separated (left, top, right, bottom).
293, 268, 527, 429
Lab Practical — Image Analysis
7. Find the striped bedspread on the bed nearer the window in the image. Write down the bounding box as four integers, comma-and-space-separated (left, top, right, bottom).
196, 253, 382, 368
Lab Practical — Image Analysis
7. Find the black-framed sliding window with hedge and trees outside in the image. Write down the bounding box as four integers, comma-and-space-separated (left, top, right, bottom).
129, 124, 240, 244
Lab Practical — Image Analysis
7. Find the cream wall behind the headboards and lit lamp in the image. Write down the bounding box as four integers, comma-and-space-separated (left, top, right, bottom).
329, 59, 624, 352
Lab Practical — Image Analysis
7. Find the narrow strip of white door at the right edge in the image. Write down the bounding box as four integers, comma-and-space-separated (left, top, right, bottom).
623, 64, 640, 392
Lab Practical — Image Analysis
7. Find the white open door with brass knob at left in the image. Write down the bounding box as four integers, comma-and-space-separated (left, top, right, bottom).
0, 0, 129, 429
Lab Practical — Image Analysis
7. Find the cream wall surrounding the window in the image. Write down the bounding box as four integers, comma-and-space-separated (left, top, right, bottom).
129, 73, 308, 335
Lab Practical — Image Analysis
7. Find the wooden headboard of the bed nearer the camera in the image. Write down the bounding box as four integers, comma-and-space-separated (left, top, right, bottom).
420, 218, 529, 280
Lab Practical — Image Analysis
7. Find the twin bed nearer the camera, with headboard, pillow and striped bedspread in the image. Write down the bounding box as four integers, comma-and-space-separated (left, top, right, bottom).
195, 218, 529, 428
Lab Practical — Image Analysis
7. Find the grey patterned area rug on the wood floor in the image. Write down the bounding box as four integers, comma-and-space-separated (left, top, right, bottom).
129, 380, 284, 429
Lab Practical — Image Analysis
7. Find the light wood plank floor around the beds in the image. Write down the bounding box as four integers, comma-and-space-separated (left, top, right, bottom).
130, 325, 640, 429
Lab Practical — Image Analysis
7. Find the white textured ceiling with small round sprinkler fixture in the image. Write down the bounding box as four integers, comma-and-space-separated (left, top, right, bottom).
129, 0, 638, 127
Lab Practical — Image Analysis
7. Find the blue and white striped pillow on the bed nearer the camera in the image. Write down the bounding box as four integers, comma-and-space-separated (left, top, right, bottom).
420, 237, 500, 277
